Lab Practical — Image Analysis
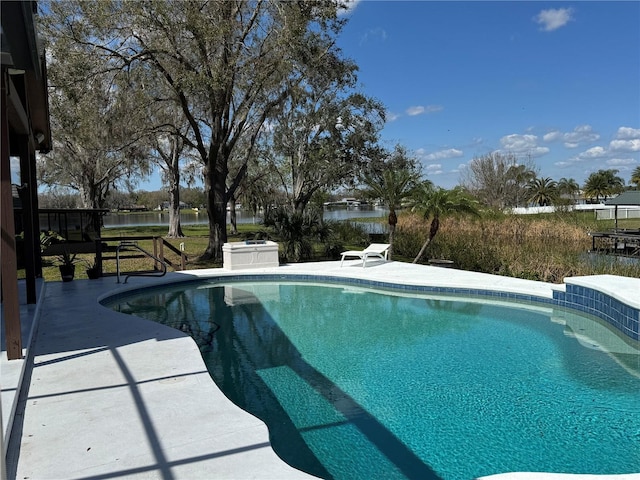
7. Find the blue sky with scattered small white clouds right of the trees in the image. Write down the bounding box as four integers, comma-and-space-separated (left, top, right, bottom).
338, 0, 640, 188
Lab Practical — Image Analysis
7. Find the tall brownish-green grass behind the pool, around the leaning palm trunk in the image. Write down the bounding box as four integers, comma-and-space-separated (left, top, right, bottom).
394, 213, 640, 283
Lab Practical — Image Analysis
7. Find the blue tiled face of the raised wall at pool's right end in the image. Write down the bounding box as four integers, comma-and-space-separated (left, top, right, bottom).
553, 284, 640, 340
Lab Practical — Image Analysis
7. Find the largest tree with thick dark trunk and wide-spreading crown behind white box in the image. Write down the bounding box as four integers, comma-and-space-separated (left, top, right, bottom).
45, 0, 356, 259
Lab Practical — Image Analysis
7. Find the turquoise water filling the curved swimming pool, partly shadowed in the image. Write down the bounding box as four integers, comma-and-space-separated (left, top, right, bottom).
108, 282, 640, 480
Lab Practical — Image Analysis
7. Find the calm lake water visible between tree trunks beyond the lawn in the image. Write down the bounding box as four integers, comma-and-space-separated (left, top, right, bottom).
104, 206, 389, 233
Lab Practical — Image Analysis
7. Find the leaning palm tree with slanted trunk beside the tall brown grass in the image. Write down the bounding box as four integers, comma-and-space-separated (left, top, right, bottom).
413, 186, 480, 263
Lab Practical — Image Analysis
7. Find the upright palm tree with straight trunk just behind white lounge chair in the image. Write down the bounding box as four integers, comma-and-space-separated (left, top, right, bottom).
364, 168, 422, 257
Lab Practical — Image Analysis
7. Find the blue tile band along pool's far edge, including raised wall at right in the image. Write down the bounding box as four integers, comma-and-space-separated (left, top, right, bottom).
100, 273, 640, 340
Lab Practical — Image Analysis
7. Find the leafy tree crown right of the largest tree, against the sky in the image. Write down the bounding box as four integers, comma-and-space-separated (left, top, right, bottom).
271, 58, 385, 212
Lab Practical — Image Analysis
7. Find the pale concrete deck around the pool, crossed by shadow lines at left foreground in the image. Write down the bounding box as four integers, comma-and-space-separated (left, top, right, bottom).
0, 260, 640, 479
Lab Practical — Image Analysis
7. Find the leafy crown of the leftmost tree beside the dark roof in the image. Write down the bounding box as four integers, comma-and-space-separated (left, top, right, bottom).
38, 10, 148, 208
